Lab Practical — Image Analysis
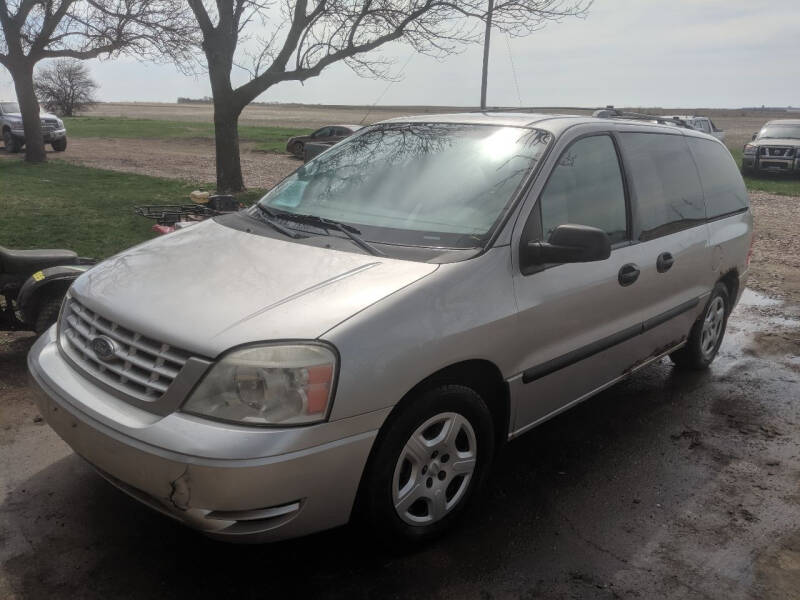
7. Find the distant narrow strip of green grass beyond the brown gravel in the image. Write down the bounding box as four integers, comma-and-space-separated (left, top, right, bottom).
64, 117, 312, 152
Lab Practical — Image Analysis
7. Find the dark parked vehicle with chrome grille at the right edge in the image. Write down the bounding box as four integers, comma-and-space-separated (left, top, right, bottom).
742, 119, 800, 174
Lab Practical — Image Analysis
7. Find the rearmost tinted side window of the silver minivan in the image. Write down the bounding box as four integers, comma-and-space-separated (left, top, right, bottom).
689, 138, 750, 219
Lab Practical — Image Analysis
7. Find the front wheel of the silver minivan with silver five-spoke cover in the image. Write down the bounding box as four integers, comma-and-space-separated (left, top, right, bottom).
362, 385, 495, 547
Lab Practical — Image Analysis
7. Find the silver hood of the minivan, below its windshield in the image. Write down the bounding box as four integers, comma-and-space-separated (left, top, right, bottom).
72, 220, 436, 357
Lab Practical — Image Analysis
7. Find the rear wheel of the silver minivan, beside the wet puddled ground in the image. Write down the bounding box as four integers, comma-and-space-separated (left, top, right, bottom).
669, 282, 731, 370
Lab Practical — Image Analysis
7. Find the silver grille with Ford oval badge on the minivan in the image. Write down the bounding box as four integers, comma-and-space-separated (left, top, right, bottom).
59, 298, 189, 402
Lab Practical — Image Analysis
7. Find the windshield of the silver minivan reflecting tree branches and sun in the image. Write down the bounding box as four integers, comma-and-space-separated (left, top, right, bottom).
260, 123, 552, 248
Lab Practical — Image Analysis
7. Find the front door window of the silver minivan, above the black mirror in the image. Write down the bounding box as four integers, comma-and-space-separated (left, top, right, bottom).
539, 135, 628, 244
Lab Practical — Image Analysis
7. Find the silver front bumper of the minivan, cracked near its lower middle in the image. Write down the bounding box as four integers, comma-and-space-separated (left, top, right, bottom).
28, 328, 386, 542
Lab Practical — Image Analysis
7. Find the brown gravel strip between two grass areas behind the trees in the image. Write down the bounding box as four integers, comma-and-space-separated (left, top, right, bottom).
48, 138, 302, 189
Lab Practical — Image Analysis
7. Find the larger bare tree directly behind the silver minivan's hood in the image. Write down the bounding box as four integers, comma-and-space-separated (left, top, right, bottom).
186, 0, 592, 191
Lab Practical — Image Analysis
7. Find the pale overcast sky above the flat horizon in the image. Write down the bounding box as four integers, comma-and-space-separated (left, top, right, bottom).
0, 0, 800, 107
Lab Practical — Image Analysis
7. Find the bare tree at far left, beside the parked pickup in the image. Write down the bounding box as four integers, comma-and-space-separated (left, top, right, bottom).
0, 0, 195, 162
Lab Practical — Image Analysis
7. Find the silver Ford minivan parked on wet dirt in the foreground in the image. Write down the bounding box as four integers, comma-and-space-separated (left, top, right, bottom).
29, 113, 752, 541
